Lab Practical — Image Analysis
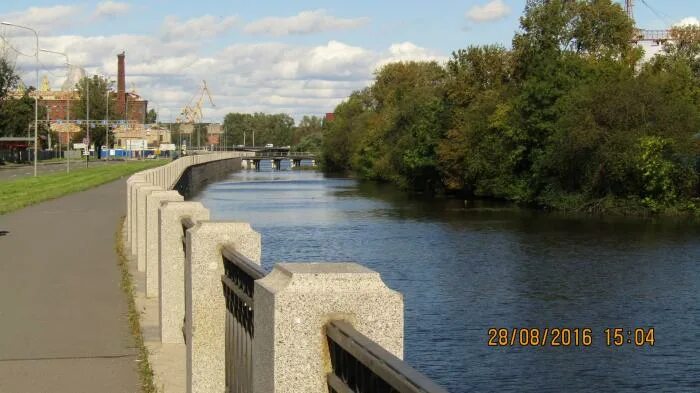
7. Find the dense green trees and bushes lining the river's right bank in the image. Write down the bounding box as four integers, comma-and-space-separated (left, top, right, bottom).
320, 0, 700, 216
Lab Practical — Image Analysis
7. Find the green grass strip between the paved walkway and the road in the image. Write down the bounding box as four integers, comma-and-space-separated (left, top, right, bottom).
0, 160, 165, 214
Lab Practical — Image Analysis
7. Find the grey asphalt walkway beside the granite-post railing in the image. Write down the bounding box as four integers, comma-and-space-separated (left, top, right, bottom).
0, 180, 139, 393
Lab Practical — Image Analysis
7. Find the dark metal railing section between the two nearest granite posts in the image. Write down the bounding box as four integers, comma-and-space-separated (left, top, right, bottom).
221, 247, 265, 393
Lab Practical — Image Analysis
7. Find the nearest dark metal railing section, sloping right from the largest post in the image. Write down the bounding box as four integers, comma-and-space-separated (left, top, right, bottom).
326, 321, 447, 393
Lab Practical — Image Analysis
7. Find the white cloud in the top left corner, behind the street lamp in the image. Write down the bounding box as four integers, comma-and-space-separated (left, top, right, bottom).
0, 5, 82, 36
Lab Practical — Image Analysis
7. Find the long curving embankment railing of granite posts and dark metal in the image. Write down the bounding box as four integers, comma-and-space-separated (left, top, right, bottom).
125, 152, 446, 393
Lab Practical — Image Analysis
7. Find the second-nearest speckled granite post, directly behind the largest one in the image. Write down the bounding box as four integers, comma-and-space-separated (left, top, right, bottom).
185, 221, 262, 393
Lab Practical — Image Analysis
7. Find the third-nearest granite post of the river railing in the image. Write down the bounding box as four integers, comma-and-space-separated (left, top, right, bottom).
158, 202, 209, 344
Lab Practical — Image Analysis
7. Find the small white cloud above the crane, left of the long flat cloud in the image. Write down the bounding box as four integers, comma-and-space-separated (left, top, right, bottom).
162, 15, 239, 41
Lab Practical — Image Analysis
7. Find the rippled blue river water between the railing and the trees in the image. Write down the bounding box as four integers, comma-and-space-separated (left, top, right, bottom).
195, 171, 700, 392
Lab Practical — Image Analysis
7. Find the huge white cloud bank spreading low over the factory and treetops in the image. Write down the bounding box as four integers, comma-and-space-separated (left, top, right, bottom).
12, 11, 442, 121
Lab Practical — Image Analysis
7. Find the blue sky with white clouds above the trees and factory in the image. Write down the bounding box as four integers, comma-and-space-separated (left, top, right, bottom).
0, 0, 700, 122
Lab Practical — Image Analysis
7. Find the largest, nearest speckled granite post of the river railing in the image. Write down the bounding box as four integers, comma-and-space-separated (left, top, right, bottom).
253, 263, 403, 393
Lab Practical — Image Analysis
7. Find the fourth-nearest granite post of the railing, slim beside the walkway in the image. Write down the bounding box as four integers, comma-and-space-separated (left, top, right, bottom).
146, 191, 184, 297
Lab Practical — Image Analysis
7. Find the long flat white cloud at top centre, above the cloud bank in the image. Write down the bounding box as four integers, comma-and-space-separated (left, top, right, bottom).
243, 10, 369, 36
